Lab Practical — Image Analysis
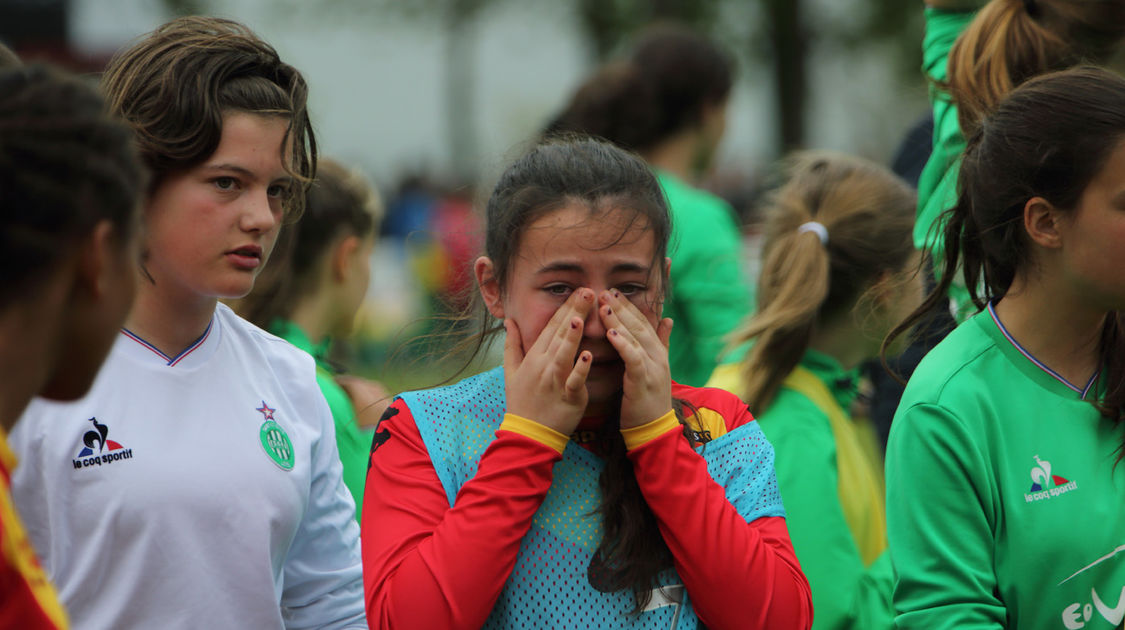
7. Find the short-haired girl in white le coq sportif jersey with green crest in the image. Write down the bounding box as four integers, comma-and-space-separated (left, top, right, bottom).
12, 17, 367, 629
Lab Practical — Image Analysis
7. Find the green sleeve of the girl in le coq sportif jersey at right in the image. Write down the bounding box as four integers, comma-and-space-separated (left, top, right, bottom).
887, 404, 1007, 630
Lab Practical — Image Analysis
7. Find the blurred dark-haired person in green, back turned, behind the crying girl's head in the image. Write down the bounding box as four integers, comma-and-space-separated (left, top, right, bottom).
547, 26, 754, 387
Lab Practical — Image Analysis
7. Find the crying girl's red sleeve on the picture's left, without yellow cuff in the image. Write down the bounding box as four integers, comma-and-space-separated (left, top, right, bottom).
361, 399, 561, 629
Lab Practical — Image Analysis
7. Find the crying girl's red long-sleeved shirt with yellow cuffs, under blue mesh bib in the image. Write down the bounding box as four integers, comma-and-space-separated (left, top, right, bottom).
361, 385, 812, 630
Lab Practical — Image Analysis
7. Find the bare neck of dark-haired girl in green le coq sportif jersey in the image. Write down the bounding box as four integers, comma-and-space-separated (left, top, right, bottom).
996, 270, 1106, 387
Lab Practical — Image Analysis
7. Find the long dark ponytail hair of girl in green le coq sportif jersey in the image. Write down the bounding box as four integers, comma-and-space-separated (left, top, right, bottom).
883, 68, 1125, 422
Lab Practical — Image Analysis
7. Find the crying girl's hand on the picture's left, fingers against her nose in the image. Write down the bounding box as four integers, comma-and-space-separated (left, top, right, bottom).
504, 288, 594, 435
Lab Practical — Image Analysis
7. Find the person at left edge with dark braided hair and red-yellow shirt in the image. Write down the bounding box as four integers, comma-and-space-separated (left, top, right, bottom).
0, 61, 145, 630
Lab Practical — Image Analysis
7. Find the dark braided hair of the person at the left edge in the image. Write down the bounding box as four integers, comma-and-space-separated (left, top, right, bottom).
0, 65, 146, 307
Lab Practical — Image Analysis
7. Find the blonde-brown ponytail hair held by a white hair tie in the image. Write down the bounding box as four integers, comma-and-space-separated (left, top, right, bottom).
731, 151, 917, 413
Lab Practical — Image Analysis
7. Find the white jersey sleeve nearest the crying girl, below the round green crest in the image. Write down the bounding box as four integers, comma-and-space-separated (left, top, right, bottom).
281, 390, 367, 630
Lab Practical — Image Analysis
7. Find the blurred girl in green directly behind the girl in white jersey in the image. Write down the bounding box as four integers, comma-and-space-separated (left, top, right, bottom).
236, 160, 390, 516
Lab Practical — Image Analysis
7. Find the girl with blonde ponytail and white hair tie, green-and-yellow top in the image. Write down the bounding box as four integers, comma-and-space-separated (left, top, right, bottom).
708, 152, 921, 630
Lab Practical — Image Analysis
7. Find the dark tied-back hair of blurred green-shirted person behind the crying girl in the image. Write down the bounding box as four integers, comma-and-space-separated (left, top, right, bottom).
547, 25, 734, 153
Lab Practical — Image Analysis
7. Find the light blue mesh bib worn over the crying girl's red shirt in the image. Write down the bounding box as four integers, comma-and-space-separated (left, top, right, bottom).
402, 368, 784, 630
